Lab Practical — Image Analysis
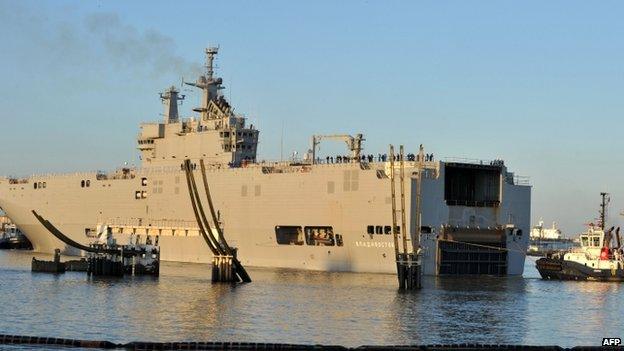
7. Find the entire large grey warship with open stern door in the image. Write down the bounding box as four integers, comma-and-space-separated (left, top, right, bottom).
0, 48, 531, 274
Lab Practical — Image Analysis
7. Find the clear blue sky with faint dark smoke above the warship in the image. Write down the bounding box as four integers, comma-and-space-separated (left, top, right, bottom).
0, 0, 624, 234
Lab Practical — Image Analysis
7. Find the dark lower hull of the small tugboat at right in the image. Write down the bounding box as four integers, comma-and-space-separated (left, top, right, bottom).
535, 258, 624, 282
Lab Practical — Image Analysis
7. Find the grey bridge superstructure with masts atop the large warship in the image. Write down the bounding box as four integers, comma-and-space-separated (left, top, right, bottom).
137, 48, 259, 166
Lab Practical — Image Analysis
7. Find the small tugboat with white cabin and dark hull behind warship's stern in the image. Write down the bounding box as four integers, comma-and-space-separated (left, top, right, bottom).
536, 193, 624, 282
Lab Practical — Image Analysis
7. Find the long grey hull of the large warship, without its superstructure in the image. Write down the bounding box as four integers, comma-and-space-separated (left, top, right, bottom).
0, 163, 530, 275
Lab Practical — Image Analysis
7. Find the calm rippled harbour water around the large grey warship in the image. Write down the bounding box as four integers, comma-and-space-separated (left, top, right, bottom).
0, 251, 624, 346
